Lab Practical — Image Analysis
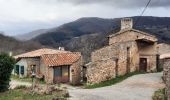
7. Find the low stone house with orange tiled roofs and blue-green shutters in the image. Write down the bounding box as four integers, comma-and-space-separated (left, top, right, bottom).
13, 48, 82, 84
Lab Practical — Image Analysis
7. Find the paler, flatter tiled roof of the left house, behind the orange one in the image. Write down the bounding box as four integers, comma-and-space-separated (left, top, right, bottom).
14, 48, 70, 59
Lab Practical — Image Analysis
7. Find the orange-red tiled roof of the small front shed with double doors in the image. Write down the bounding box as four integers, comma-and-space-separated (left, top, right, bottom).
41, 52, 81, 66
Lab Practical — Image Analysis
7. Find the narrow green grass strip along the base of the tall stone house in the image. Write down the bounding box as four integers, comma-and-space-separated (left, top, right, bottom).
85, 72, 143, 89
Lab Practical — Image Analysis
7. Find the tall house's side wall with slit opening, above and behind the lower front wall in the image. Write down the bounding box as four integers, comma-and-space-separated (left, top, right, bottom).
91, 41, 139, 75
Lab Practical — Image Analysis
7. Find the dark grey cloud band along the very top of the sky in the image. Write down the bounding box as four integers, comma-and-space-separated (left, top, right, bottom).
33, 0, 170, 8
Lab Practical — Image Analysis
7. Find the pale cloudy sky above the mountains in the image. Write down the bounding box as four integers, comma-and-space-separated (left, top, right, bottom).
0, 0, 170, 36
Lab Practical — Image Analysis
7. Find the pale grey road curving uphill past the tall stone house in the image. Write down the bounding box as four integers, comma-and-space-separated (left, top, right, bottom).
69, 73, 164, 100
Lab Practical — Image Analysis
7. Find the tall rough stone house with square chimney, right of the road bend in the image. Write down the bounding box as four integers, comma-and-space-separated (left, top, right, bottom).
86, 18, 157, 84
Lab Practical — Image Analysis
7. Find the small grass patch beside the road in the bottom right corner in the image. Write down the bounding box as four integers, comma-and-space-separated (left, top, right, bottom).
152, 88, 167, 100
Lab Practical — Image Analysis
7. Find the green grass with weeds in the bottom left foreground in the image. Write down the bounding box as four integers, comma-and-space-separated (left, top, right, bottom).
0, 89, 66, 100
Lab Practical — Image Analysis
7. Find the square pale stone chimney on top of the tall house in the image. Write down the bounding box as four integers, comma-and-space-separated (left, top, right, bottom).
121, 18, 133, 30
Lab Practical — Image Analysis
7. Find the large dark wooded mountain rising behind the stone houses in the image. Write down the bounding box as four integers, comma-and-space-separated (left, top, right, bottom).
27, 16, 170, 62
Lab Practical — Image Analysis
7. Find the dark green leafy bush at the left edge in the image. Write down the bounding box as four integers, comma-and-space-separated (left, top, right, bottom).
0, 53, 15, 92
